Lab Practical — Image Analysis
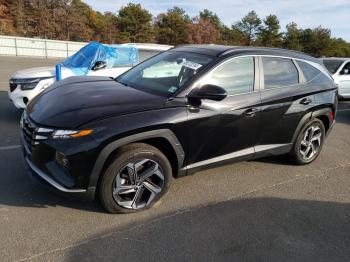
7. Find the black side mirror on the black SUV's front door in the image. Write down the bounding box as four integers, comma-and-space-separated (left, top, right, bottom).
187, 85, 227, 101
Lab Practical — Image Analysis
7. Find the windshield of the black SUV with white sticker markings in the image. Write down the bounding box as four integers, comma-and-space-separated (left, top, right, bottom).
117, 51, 213, 96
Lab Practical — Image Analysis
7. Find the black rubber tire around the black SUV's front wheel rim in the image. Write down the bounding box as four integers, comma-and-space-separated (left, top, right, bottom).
98, 143, 172, 214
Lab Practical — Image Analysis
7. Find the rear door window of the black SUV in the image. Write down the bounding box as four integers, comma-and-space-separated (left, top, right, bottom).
262, 57, 299, 89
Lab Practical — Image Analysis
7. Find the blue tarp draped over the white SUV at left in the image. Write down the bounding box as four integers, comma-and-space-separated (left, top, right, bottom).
62, 42, 138, 75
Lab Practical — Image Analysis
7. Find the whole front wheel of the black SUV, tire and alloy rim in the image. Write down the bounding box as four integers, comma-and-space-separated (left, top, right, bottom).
99, 143, 172, 213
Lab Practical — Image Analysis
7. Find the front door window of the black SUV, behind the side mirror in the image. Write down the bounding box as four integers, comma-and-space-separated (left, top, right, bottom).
201, 57, 254, 95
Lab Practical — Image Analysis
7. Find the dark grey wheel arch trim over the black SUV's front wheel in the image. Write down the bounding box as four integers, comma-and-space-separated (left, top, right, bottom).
89, 129, 185, 188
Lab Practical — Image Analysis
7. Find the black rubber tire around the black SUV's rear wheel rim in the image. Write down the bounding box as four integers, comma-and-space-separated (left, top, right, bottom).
289, 118, 326, 165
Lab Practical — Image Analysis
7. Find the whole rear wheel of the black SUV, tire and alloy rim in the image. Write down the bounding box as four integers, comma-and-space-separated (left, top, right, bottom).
290, 119, 325, 165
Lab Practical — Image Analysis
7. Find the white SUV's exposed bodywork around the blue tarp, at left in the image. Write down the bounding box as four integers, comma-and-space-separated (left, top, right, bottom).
8, 43, 172, 109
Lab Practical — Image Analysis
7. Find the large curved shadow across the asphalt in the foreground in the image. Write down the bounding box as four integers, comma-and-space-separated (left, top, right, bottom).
65, 198, 350, 262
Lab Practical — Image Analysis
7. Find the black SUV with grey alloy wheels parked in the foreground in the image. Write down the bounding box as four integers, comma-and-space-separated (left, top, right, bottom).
21, 45, 337, 213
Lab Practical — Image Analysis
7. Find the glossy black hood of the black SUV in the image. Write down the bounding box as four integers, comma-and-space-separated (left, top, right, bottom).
27, 76, 166, 129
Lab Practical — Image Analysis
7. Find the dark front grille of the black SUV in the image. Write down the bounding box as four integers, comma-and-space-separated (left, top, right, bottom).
21, 113, 53, 151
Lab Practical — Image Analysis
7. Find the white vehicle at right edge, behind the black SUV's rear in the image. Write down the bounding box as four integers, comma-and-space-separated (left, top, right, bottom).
323, 58, 350, 99
